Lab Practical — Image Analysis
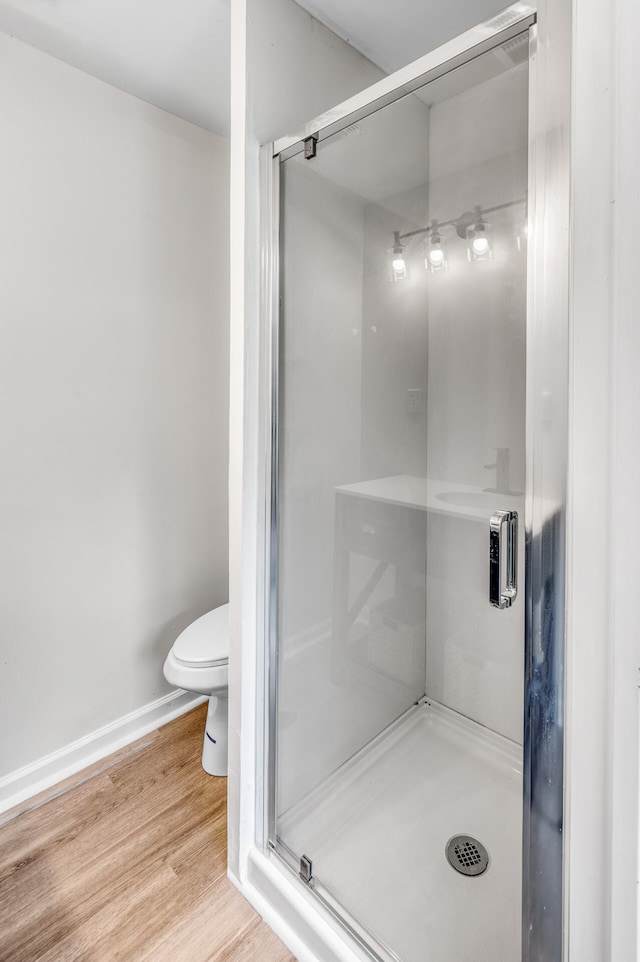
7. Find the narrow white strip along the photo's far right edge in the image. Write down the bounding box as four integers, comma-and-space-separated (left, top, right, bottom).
610, 0, 640, 959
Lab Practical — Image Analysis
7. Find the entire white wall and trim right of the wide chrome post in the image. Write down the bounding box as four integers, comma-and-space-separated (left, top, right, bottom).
565, 0, 640, 962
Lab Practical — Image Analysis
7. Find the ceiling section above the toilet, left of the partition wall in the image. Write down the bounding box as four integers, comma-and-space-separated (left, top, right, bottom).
0, 0, 230, 136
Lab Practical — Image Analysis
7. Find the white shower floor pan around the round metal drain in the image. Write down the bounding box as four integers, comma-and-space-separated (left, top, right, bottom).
278, 700, 522, 962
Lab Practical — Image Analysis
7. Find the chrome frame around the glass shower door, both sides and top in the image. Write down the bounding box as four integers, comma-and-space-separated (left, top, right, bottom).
256, 0, 571, 962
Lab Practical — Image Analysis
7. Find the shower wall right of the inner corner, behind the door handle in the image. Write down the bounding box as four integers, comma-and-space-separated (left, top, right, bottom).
426, 69, 527, 741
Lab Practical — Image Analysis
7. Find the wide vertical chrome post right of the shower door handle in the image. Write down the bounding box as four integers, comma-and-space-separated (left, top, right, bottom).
522, 9, 571, 962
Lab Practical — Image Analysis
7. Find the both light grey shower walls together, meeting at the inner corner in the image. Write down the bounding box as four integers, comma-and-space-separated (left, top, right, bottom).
278, 62, 527, 796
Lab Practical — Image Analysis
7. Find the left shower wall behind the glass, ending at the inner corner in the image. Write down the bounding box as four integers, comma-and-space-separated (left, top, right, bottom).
278, 98, 428, 812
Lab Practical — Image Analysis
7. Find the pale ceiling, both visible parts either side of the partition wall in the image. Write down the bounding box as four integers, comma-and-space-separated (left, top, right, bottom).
0, 0, 506, 136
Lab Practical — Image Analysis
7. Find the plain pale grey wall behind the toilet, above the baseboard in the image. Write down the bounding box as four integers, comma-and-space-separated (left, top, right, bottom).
0, 35, 228, 776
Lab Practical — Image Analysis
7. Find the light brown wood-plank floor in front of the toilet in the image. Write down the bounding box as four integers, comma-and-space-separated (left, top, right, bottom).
0, 705, 293, 962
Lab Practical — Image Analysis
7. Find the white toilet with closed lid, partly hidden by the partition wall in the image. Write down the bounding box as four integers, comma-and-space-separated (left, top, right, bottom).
163, 604, 229, 775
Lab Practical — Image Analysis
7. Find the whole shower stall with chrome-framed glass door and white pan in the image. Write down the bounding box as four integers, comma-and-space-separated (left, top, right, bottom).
260, 4, 563, 962
